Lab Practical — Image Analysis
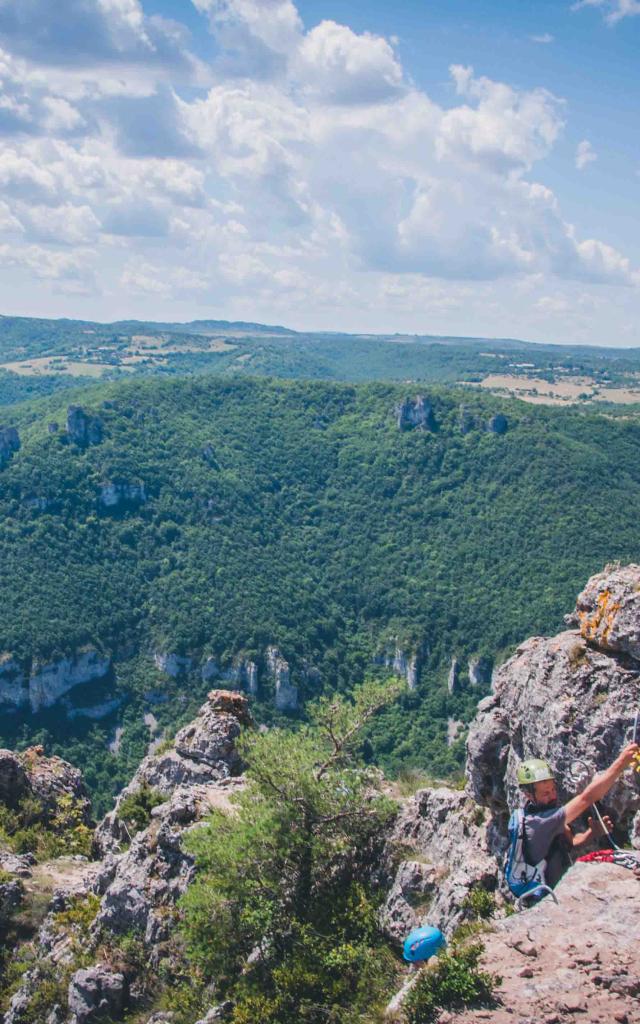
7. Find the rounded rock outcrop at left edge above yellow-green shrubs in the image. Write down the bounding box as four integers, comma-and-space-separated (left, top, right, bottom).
0, 746, 91, 825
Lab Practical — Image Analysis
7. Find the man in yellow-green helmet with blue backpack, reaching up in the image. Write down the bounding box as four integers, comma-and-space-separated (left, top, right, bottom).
507, 742, 640, 895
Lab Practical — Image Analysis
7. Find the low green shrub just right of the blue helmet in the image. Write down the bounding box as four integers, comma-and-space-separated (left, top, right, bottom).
403, 942, 502, 1024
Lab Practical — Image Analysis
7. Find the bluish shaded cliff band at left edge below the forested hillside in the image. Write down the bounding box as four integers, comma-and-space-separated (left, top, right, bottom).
0, 647, 112, 712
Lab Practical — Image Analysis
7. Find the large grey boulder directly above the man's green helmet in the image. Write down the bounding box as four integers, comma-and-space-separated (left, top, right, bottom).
467, 631, 640, 833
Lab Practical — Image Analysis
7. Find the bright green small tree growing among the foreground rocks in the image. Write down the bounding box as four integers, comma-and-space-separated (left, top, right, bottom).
178, 683, 399, 1024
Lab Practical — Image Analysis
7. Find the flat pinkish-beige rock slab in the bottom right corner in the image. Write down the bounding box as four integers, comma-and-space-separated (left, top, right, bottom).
449, 864, 640, 1024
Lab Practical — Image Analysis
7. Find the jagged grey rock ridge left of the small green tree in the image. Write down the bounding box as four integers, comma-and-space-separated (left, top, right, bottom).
0, 690, 251, 1024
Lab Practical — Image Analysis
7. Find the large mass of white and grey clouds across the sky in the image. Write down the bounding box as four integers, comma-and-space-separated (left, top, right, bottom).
0, 0, 638, 333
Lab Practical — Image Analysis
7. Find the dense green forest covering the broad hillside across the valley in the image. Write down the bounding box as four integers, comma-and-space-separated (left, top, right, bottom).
0, 376, 640, 801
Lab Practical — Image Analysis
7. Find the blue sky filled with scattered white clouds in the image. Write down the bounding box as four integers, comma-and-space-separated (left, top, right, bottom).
0, 0, 640, 346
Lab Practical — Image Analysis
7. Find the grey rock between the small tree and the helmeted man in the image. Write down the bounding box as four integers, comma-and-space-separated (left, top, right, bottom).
381, 787, 499, 942
